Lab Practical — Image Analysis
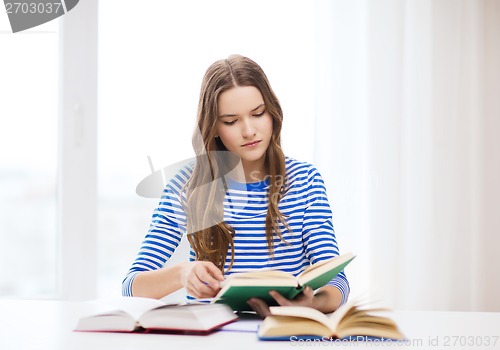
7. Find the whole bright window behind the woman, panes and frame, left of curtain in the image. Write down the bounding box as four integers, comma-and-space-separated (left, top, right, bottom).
0, 0, 315, 298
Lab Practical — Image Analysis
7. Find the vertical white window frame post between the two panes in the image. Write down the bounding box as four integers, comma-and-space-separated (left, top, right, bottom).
57, 0, 98, 300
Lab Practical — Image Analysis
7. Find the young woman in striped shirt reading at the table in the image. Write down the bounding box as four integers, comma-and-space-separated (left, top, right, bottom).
123, 55, 349, 316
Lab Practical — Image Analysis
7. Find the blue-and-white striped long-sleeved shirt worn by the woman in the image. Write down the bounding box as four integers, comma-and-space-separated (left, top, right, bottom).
122, 157, 349, 303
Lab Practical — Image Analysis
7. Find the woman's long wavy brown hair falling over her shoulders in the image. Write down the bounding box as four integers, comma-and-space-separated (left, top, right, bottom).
184, 55, 289, 272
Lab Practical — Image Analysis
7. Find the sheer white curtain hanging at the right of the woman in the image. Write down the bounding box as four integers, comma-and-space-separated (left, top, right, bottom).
315, 0, 500, 311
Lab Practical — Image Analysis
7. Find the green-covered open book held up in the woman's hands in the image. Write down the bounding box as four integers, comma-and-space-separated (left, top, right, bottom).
212, 253, 354, 311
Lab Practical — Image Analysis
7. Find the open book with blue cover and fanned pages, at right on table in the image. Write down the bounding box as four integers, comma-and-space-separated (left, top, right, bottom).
258, 300, 405, 340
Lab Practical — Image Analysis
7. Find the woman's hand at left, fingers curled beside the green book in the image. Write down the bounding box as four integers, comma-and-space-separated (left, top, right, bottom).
180, 261, 224, 298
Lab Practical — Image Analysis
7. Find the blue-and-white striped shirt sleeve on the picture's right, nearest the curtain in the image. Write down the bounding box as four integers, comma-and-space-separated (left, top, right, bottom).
302, 166, 350, 305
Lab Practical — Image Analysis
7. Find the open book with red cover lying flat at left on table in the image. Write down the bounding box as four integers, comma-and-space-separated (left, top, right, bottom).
75, 297, 238, 334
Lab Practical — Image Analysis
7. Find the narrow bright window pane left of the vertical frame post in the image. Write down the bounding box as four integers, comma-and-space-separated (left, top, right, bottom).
0, 16, 59, 297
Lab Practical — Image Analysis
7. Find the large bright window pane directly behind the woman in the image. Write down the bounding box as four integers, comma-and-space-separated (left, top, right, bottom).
98, 0, 315, 296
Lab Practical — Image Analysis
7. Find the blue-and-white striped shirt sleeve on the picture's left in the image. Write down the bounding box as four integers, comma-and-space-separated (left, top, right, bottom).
122, 173, 186, 296
